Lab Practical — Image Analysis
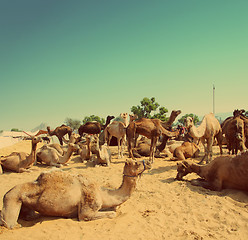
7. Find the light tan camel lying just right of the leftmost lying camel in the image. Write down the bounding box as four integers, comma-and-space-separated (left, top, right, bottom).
36, 143, 79, 167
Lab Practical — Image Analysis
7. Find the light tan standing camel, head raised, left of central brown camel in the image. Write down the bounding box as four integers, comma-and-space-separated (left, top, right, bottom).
104, 113, 128, 158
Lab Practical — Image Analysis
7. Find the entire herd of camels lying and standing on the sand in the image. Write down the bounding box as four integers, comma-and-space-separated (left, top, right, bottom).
0, 110, 248, 229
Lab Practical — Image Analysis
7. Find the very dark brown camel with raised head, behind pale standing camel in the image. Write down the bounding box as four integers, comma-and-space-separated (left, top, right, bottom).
78, 116, 115, 137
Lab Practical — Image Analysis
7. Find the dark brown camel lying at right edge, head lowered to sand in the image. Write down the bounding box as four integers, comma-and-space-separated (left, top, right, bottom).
176, 152, 248, 191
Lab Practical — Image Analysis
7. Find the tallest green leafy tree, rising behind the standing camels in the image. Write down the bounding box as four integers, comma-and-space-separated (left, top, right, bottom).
131, 97, 168, 121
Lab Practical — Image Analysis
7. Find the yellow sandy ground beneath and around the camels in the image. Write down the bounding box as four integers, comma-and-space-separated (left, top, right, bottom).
0, 141, 248, 240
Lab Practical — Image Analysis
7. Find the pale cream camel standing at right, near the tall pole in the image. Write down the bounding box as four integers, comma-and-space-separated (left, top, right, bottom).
185, 113, 222, 164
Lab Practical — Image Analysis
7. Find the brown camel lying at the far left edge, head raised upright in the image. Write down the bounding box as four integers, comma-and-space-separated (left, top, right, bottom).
0, 137, 41, 173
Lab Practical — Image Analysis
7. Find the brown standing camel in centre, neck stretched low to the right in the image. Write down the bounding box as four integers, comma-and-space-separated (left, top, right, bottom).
127, 118, 178, 162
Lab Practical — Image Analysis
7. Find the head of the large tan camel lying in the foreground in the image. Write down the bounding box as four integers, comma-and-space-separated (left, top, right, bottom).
123, 159, 151, 177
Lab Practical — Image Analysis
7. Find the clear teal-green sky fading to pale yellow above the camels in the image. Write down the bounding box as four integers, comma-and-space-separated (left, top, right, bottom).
0, 0, 248, 130
